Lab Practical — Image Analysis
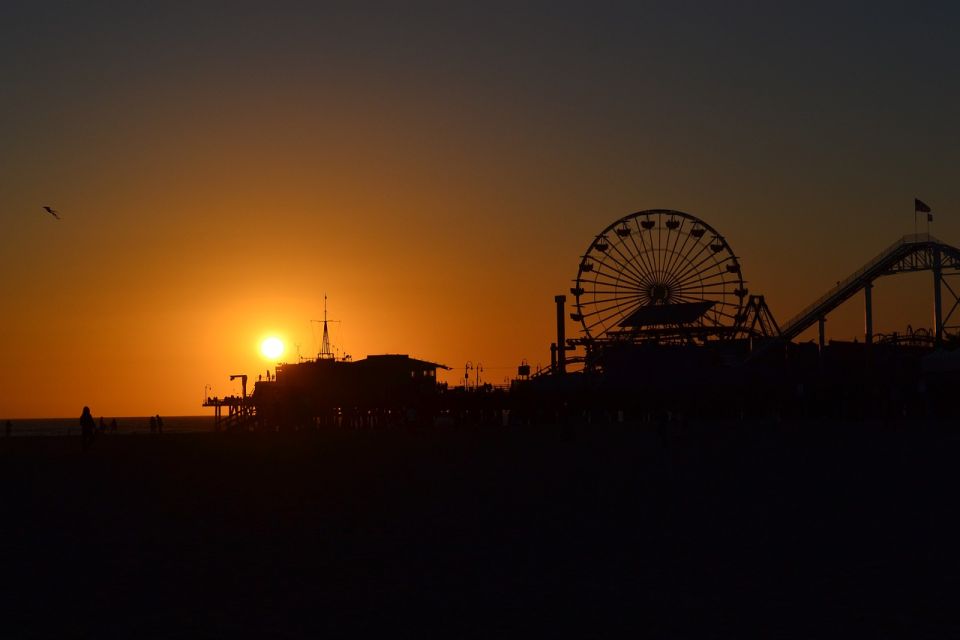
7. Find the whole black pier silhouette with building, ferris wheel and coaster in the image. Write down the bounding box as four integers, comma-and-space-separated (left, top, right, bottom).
205, 209, 960, 429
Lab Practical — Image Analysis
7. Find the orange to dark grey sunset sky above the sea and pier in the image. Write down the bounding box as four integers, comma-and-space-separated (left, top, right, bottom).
0, 1, 960, 418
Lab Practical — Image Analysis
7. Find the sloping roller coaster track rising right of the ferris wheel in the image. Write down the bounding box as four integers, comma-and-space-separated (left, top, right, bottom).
780, 233, 960, 340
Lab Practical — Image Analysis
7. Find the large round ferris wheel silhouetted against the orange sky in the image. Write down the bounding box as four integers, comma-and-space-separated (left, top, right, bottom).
570, 209, 747, 341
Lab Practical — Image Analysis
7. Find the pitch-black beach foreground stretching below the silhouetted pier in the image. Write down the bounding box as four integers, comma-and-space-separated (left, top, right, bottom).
0, 424, 960, 638
